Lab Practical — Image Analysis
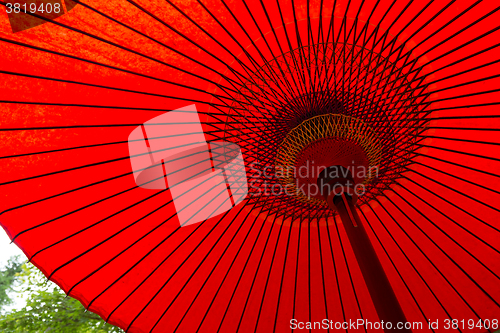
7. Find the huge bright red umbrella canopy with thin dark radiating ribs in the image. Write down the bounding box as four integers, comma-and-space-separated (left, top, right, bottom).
0, 0, 500, 332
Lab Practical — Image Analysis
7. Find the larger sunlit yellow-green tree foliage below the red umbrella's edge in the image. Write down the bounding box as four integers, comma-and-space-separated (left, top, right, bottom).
0, 263, 123, 333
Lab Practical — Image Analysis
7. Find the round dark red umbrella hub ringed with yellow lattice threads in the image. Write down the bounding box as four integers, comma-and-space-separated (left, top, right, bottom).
275, 114, 382, 207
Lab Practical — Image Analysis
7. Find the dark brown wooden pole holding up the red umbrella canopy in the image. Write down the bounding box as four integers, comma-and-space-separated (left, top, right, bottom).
318, 167, 411, 332
